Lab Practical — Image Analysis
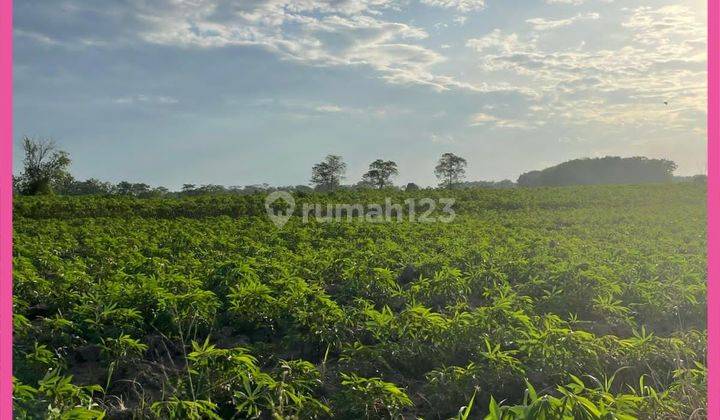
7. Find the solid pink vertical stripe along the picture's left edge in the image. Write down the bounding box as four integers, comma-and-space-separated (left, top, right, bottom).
0, 0, 13, 420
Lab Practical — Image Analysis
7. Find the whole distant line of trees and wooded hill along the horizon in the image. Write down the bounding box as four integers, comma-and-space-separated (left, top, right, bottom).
13, 138, 707, 198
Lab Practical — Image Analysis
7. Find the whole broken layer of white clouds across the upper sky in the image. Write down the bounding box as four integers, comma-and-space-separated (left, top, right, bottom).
15, 0, 706, 148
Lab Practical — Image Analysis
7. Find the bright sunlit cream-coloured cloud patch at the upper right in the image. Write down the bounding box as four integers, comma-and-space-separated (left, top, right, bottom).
466, 6, 705, 135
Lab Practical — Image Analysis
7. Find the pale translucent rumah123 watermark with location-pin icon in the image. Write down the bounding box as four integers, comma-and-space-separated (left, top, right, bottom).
265, 191, 455, 228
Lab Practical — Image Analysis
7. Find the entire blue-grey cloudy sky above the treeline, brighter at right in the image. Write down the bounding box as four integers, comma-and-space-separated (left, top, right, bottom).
14, 0, 706, 188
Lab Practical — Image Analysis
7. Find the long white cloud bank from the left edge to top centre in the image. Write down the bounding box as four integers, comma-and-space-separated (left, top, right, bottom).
16, 0, 484, 91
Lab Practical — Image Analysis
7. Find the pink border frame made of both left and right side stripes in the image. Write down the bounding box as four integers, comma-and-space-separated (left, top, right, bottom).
0, 0, 720, 420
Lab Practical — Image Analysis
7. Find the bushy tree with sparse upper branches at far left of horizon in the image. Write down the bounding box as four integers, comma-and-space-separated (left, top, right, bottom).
17, 137, 71, 195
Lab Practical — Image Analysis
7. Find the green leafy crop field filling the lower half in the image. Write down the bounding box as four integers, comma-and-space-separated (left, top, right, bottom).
14, 183, 706, 419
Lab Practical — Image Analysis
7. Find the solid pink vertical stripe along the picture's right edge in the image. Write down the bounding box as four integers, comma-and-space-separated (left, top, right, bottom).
707, 0, 720, 419
